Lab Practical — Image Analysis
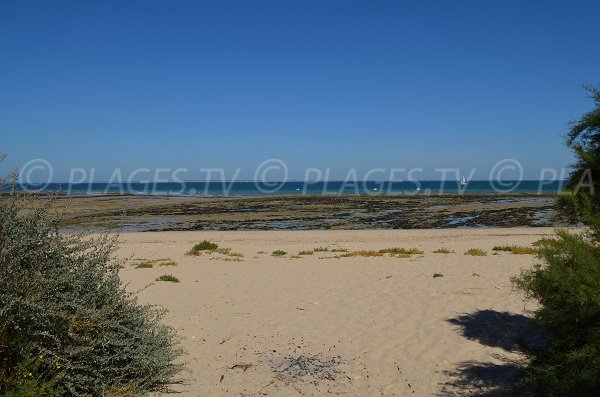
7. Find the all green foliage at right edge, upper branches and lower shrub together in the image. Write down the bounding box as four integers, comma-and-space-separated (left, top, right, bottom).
513, 88, 600, 397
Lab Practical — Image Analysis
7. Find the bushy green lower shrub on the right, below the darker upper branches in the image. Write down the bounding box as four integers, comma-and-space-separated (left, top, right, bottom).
513, 227, 600, 397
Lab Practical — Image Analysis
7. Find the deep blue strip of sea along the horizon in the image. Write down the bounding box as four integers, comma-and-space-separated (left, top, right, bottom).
15, 180, 565, 197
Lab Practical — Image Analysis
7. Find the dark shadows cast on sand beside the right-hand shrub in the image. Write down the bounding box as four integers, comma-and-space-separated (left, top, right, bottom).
438, 310, 546, 397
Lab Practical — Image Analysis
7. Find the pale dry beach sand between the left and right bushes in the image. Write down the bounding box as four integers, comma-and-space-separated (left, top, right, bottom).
115, 228, 580, 396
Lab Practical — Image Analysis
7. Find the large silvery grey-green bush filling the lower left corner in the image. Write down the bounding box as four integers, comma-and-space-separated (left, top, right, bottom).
0, 169, 182, 397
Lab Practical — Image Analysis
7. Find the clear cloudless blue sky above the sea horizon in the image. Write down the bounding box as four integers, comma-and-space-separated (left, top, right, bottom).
0, 0, 600, 180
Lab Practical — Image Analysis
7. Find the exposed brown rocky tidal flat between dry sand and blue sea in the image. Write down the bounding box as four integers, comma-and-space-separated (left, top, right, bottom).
41, 193, 573, 232
